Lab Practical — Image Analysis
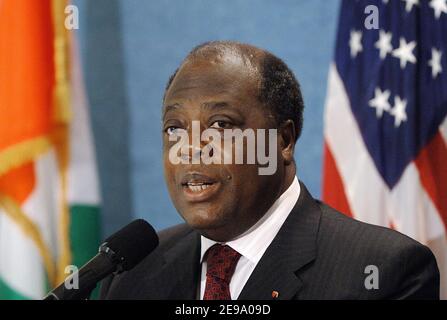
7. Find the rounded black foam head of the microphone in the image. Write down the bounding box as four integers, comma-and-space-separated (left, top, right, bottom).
102, 219, 158, 271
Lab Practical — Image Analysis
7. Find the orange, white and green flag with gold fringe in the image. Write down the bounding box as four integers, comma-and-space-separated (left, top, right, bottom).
0, 0, 100, 299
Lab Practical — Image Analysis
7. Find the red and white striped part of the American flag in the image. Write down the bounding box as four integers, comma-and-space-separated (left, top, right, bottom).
323, 64, 447, 299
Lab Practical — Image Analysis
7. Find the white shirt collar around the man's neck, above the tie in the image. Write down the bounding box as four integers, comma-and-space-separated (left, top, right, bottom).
200, 176, 301, 264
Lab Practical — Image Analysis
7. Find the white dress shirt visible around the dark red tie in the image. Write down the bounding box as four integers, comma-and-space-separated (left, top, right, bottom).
200, 176, 300, 300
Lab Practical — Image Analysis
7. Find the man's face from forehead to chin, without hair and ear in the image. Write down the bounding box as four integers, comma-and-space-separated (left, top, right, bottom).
163, 61, 284, 241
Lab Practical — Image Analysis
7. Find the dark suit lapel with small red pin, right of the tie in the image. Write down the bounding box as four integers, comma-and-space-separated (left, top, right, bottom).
238, 183, 321, 300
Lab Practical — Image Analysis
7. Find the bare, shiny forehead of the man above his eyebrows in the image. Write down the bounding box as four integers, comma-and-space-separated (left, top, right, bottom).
165, 57, 260, 105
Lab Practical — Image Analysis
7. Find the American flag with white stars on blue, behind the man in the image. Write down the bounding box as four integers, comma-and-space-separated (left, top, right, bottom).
323, 0, 447, 299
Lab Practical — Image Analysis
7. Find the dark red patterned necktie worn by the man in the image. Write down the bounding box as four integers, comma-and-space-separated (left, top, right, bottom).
203, 244, 241, 300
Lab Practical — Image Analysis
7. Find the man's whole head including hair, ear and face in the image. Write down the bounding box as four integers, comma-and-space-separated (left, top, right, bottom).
163, 42, 303, 241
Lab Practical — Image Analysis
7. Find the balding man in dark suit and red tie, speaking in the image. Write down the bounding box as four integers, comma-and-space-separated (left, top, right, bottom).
101, 42, 439, 299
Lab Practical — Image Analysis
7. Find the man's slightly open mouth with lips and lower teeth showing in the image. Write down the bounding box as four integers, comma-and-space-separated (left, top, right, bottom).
181, 173, 220, 202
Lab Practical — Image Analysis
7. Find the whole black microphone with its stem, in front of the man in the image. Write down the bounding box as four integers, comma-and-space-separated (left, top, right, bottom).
43, 219, 158, 300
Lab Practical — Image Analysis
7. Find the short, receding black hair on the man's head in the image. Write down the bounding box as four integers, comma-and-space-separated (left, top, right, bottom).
163, 41, 304, 141
